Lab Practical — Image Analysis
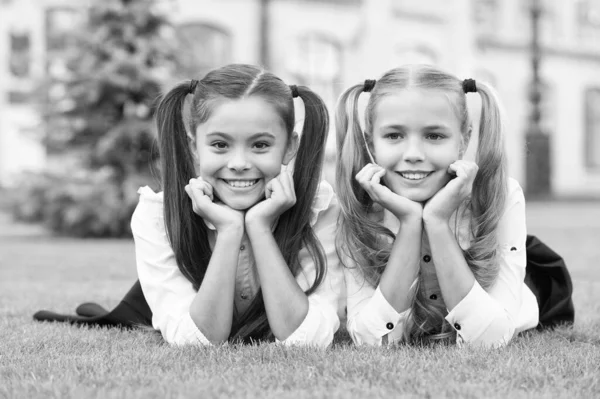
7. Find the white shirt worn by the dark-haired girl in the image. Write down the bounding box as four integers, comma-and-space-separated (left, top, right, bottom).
131, 181, 344, 346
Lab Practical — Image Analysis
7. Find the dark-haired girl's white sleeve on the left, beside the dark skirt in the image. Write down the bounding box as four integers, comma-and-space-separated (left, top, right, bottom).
131, 187, 210, 345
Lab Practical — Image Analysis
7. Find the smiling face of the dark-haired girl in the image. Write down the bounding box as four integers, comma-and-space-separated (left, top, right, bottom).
196, 96, 297, 210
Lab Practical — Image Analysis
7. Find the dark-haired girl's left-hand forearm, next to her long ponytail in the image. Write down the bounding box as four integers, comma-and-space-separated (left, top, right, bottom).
190, 229, 244, 343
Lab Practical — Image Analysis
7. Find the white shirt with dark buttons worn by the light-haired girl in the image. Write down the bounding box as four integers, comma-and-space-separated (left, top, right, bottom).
344, 179, 539, 346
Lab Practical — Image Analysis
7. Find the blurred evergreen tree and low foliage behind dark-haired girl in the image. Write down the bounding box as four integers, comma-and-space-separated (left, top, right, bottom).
14, 0, 177, 236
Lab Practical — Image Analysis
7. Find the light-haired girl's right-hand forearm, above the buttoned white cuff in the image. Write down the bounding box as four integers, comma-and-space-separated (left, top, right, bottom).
425, 220, 475, 310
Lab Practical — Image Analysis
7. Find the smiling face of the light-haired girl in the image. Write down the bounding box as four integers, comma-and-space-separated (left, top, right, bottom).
373, 89, 461, 202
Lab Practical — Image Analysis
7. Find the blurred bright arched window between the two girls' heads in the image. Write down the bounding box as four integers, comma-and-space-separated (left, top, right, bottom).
288, 33, 342, 109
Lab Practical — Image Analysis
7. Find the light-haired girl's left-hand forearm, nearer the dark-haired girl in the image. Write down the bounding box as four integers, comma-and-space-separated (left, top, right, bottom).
379, 219, 423, 312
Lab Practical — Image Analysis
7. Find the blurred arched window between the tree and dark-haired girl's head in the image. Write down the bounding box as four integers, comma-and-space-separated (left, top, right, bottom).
177, 23, 232, 77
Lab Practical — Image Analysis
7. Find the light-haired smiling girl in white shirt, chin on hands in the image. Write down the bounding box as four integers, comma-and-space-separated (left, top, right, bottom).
336, 66, 573, 346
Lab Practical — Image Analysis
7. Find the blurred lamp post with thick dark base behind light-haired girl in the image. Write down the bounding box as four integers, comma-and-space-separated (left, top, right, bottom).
525, 0, 552, 198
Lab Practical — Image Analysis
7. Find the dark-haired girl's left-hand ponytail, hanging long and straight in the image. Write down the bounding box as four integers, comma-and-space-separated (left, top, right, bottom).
156, 81, 212, 290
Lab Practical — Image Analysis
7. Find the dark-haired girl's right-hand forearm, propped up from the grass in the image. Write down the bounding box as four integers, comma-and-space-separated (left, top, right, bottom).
247, 225, 308, 341
